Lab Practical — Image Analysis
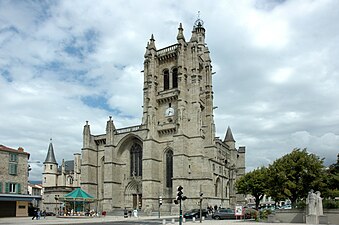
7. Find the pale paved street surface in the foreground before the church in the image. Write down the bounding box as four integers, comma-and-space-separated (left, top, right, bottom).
0, 216, 310, 225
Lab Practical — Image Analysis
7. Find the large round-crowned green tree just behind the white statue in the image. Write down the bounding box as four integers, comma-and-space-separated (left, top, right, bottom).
267, 149, 324, 207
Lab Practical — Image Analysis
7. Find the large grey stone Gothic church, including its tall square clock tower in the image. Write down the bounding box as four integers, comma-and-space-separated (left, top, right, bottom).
80, 20, 245, 213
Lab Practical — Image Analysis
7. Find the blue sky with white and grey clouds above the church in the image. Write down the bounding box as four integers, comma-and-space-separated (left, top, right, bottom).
0, 0, 339, 180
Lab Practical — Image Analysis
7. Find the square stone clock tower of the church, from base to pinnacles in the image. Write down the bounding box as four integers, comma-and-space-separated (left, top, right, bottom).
142, 19, 216, 211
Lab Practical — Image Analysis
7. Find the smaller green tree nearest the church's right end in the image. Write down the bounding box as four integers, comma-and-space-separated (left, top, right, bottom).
235, 167, 267, 209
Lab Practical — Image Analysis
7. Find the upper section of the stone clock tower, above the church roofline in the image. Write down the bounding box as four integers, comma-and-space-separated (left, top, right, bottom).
143, 19, 214, 144
